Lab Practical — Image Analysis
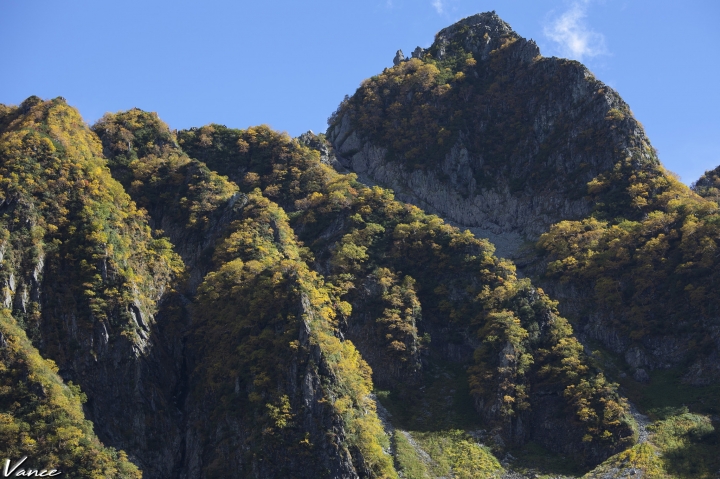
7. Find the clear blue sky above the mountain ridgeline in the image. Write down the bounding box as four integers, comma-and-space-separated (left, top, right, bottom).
0, 0, 720, 183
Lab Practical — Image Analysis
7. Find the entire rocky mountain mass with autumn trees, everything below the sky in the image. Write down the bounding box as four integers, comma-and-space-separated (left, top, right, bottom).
0, 12, 720, 479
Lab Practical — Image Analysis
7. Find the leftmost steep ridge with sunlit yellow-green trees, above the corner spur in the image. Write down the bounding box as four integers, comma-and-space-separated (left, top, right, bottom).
0, 97, 181, 476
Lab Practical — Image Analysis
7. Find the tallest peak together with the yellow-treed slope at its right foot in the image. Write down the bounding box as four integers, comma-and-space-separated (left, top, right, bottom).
327, 13, 720, 404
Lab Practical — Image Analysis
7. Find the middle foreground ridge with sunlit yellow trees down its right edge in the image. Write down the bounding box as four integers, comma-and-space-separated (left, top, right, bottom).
94, 110, 396, 478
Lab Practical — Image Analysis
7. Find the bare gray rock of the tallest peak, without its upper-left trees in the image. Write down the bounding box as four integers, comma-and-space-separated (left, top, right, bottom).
327, 18, 649, 257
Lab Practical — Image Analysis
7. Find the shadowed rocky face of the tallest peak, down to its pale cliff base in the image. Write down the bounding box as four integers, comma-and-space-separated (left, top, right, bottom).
327, 13, 651, 255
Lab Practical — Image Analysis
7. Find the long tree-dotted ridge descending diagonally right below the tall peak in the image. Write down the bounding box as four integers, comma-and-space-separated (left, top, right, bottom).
178, 125, 633, 463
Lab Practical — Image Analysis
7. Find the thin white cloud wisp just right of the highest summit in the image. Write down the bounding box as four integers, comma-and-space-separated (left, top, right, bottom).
544, 0, 607, 61
